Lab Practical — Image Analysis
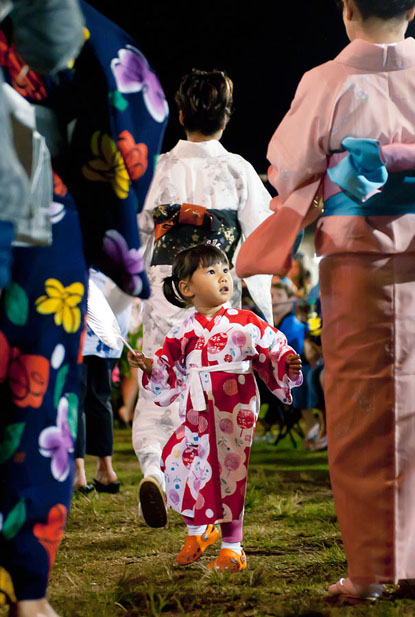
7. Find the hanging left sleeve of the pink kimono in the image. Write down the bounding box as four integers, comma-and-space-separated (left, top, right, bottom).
236, 67, 334, 277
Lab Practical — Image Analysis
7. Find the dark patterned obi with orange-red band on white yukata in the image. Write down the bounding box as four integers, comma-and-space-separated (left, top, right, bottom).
151, 204, 241, 266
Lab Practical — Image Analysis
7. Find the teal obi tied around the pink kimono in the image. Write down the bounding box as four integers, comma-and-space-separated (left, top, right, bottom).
323, 137, 415, 216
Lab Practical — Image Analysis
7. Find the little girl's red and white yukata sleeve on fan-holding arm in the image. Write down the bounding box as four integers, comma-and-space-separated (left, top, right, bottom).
142, 333, 186, 407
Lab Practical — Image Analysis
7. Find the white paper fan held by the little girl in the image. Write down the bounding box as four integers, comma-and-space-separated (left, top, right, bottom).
87, 278, 135, 353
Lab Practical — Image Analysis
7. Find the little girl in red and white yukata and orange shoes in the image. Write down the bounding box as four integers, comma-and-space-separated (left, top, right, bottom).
130, 244, 302, 570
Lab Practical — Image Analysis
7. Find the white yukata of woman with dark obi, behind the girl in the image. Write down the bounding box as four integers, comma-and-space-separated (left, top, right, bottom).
133, 140, 272, 488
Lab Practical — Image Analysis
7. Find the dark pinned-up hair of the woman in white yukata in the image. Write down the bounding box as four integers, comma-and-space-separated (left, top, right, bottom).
175, 69, 233, 136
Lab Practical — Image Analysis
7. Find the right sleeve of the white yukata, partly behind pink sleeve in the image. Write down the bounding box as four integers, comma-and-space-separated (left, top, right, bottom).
238, 160, 274, 324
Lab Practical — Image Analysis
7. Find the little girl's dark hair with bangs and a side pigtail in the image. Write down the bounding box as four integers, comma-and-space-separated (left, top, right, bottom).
163, 244, 229, 308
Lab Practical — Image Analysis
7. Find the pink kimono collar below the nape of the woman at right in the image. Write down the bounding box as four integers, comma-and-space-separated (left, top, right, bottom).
334, 37, 415, 71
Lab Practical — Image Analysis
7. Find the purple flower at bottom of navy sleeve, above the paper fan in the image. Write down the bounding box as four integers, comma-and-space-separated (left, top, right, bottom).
103, 229, 144, 296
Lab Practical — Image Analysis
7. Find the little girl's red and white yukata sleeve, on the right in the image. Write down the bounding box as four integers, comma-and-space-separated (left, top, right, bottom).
252, 320, 303, 404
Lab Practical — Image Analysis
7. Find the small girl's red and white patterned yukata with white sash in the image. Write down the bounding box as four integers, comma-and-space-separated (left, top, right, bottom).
143, 306, 302, 525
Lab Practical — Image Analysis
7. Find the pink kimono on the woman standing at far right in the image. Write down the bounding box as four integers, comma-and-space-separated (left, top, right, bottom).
236, 38, 415, 584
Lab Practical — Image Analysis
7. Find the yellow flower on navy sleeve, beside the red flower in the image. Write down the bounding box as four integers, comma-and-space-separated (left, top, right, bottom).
82, 131, 130, 199
